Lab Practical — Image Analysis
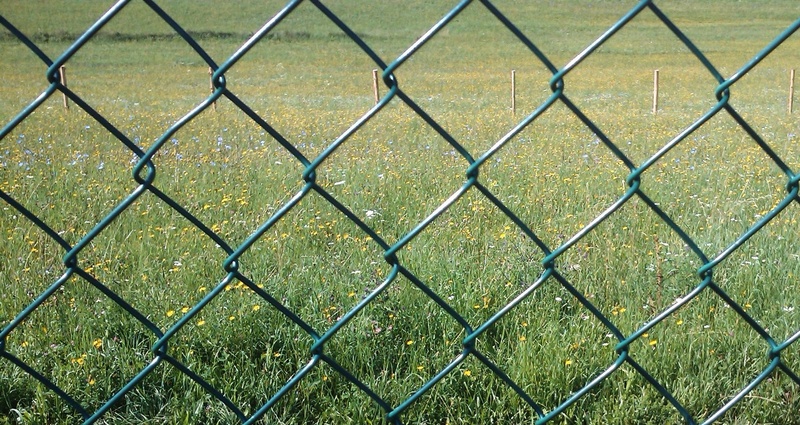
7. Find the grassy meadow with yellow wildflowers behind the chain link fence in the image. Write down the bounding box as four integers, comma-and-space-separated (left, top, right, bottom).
0, 0, 800, 424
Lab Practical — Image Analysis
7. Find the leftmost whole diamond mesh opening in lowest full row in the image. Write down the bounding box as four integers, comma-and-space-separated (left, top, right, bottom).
2, 275, 155, 420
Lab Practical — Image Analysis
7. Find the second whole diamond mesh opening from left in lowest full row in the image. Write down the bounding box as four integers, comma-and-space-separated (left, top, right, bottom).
156, 274, 312, 415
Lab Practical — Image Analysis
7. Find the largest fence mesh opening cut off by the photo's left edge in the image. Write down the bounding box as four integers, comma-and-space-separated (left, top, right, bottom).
0, 111, 136, 244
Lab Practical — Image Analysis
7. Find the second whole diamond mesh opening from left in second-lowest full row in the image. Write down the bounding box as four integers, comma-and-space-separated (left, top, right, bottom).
234, 193, 388, 335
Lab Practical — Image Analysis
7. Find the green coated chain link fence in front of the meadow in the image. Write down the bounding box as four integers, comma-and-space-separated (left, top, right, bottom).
0, 0, 800, 424
